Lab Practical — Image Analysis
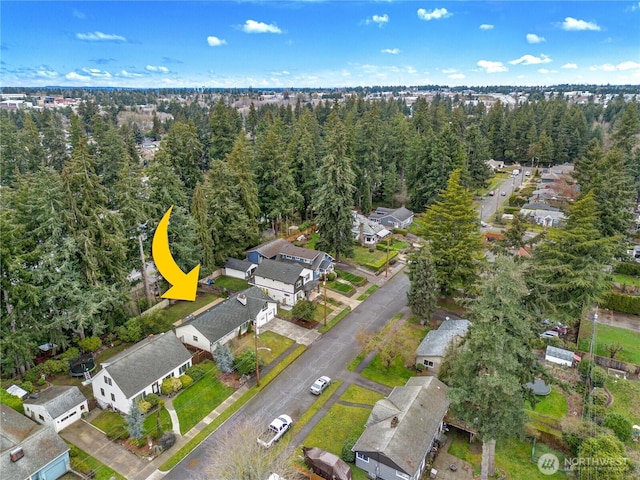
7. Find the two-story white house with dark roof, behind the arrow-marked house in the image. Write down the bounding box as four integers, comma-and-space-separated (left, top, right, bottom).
249, 258, 319, 306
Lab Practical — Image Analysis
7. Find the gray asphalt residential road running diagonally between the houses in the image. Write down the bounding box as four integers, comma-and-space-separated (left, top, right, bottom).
164, 264, 409, 480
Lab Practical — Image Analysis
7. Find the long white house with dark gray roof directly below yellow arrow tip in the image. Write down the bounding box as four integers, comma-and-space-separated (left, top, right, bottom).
176, 287, 278, 355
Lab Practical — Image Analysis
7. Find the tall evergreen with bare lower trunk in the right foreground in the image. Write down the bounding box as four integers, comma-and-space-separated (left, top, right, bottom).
447, 257, 539, 480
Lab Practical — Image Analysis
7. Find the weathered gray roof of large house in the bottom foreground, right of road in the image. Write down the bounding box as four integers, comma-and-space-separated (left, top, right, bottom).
353, 377, 449, 476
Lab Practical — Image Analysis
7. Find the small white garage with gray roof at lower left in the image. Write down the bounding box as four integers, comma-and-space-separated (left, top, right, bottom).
24, 385, 89, 433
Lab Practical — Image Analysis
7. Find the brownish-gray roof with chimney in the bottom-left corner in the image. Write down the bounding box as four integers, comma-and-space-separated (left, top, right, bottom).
0, 405, 69, 480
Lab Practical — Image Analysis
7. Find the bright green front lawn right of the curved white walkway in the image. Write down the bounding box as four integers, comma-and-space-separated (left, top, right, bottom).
173, 361, 233, 435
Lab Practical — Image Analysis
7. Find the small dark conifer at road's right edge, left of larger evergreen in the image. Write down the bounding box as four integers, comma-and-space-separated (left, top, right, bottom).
407, 245, 438, 325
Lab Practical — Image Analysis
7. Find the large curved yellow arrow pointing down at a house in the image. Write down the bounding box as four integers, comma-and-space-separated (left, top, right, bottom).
151, 205, 200, 302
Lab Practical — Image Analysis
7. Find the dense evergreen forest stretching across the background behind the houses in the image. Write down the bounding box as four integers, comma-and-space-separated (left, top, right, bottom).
0, 90, 640, 373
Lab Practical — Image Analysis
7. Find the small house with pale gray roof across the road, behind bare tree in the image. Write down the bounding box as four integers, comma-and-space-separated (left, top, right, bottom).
416, 318, 471, 375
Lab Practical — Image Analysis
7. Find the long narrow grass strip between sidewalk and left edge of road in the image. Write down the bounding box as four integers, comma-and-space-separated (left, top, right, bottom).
159, 345, 307, 472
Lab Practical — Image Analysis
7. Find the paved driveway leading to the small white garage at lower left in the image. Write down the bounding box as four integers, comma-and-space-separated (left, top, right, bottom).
60, 420, 149, 478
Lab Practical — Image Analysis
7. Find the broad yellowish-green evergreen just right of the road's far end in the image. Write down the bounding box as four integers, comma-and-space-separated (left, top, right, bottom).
418, 170, 483, 296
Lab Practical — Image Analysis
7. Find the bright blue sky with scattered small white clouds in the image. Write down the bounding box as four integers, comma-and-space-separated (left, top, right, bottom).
0, 0, 640, 88
